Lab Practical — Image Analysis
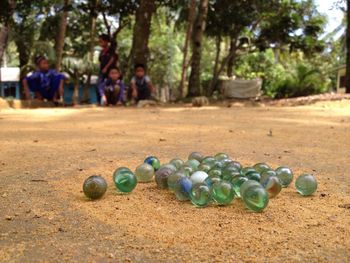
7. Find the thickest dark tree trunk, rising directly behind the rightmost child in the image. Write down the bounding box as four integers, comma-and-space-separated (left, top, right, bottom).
131, 0, 156, 68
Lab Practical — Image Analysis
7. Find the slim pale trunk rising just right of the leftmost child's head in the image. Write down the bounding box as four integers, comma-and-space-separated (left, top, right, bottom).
55, 0, 70, 71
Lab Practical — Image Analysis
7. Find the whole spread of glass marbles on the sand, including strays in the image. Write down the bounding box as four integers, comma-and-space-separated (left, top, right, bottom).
83, 152, 317, 212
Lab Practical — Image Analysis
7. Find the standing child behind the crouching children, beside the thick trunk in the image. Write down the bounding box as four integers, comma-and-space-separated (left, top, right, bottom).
97, 34, 118, 101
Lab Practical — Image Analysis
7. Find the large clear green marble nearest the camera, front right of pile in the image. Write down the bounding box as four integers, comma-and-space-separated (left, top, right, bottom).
242, 185, 269, 212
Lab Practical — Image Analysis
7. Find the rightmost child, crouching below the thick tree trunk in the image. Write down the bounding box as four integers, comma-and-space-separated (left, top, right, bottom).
130, 64, 155, 102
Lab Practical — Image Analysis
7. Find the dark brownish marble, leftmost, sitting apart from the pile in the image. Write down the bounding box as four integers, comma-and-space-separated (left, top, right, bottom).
83, 175, 107, 200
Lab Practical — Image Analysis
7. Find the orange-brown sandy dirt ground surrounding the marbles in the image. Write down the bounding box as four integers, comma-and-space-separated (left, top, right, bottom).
0, 101, 350, 262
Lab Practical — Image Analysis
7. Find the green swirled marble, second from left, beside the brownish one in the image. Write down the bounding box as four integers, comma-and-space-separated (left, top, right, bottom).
113, 168, 137, 193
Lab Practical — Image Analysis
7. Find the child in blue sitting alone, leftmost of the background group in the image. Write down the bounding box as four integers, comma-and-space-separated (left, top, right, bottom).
22, 56, 65, 103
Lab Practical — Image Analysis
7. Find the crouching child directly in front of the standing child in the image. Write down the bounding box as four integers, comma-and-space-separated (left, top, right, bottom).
98, 67, 125, 106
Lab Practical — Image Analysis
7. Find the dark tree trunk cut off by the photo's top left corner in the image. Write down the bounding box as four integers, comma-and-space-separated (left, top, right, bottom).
0, 0, 16, 66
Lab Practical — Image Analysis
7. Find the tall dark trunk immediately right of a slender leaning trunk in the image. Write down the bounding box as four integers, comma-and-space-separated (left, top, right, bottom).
188, 0, 209, 97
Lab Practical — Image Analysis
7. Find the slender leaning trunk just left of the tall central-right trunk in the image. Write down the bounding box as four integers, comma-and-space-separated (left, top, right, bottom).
179, 0, 196, 98
